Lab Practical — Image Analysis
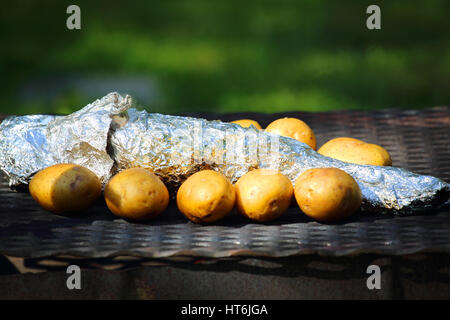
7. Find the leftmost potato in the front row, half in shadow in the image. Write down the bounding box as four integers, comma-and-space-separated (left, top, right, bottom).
29, 164, 102, 213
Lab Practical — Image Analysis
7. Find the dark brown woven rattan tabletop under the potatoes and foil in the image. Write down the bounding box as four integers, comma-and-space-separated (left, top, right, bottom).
0, 107, 450, 257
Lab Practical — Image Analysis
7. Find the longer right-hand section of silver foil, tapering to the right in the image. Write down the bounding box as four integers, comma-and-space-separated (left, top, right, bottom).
111, 101, 450, 213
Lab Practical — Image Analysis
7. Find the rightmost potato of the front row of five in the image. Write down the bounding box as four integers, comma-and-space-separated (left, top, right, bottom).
294, 168, 362, 221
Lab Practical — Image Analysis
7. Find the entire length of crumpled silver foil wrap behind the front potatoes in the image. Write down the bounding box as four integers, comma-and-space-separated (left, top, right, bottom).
0, 93, 450, 213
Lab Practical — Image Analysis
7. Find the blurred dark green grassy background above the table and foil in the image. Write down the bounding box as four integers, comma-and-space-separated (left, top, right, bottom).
0, 0, 450, 114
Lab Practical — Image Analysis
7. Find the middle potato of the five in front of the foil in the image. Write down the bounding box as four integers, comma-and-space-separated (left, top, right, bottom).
177, 170, 236, 223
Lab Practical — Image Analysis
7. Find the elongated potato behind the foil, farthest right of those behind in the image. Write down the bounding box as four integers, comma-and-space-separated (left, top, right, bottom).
317, 137, 392, 166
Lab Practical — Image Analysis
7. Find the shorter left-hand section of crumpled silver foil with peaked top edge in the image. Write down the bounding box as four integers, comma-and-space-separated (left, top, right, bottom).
0, 93, 131, 187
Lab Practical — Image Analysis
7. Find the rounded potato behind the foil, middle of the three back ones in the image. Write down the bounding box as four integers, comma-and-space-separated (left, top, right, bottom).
266, 118, 316, 150
